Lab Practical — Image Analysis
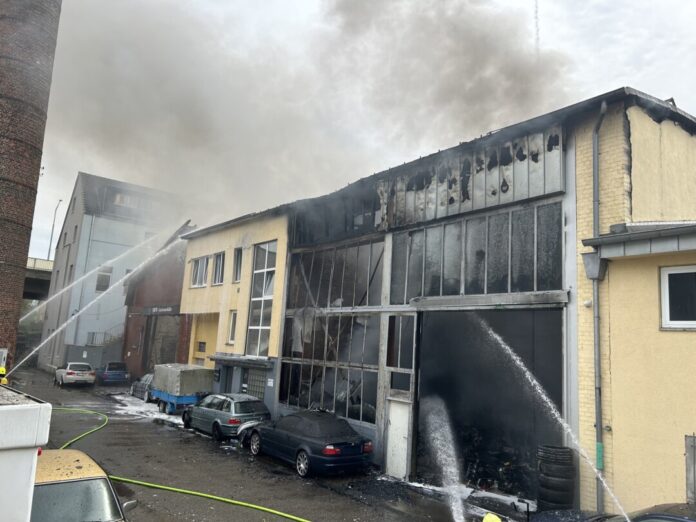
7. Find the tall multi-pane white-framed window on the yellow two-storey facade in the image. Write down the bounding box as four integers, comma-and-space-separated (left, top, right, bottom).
246, 241, 278, 357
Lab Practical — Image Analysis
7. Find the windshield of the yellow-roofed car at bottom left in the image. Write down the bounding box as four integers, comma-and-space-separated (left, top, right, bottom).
31, 478, 123, 522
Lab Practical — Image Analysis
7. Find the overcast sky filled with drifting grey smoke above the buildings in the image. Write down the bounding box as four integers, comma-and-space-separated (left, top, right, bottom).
30, 0, 696, 257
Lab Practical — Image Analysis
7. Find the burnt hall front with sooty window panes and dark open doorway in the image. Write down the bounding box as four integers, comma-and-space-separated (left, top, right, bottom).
278, 112, 573, 497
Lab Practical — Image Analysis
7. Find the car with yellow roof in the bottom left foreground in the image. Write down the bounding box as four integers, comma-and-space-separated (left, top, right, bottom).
31, 449, 137, 522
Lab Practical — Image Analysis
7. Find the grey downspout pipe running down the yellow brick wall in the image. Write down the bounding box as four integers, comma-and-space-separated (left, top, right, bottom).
592, 101, 607, 513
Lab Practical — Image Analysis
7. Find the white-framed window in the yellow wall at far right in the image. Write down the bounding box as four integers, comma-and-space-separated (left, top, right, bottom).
660, 265, 696, 329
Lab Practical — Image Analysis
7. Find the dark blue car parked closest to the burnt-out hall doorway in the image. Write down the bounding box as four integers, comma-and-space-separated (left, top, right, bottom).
249, 410, 373, 477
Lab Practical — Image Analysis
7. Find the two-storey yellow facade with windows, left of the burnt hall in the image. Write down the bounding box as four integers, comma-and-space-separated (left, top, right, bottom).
181, 211, 288, 405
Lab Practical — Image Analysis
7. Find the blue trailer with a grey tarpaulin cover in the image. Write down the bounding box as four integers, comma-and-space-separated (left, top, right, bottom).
150, 364, 214, 415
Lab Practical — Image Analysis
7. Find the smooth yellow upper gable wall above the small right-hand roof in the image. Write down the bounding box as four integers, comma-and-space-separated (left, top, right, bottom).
627, 107, 696, 221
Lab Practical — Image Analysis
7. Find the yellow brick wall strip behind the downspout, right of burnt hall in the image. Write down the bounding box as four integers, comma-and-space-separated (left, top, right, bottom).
573, 104, 631, 510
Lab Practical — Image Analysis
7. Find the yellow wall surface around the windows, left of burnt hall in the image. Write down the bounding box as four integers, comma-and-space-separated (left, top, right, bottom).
181, 216, 288, 357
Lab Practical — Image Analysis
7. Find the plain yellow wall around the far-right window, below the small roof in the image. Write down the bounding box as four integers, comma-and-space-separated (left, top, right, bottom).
604, 253, 696, 510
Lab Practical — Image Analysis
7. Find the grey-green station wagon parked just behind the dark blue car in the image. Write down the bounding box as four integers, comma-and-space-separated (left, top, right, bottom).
181, 393, 271, 441
